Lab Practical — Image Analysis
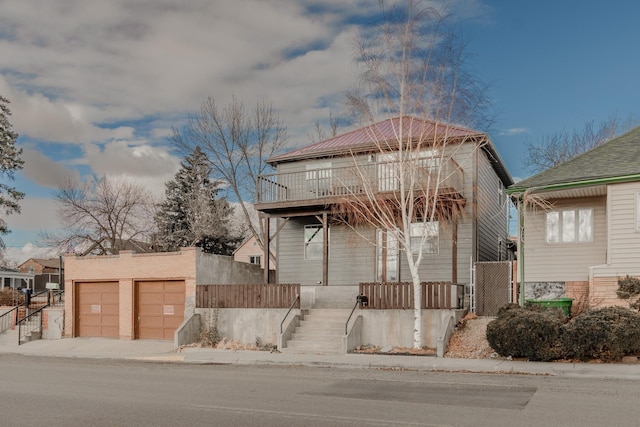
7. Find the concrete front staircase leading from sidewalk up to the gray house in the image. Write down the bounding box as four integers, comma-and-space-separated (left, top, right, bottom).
282, 308, 351, 354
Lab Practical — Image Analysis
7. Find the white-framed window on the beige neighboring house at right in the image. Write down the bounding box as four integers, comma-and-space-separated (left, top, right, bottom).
546, 208, 593, 244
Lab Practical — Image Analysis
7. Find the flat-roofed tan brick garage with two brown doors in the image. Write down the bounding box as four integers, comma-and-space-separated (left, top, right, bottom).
64, 247, 263, 342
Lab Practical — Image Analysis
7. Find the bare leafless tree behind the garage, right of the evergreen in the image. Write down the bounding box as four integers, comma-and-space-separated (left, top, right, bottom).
172, 97, 287, 253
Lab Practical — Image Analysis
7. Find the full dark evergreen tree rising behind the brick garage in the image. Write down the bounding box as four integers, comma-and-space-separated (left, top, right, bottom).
156, 147, 239, 255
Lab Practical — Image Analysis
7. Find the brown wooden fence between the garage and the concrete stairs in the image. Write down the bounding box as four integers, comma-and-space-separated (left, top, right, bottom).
196, 283, 300, 308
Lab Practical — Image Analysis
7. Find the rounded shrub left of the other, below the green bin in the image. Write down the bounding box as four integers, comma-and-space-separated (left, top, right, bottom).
487, 305, 562, 360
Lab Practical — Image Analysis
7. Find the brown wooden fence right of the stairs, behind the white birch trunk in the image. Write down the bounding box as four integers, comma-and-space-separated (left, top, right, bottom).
360, 282, 463, 310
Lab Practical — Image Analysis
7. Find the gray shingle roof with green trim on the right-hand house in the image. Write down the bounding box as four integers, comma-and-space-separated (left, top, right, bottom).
509, 126, 640, 192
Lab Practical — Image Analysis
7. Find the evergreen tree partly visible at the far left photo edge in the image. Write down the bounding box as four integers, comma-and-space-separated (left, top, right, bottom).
0, 95, 24, 249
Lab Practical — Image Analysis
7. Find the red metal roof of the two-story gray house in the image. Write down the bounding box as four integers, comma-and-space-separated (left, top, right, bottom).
268, 116, 482, 164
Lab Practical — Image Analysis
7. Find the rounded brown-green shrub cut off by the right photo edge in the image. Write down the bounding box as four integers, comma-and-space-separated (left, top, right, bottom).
563, 307, 640, 361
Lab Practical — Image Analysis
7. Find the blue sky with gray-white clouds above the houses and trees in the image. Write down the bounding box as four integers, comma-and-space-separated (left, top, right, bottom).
0, 0, 640, 262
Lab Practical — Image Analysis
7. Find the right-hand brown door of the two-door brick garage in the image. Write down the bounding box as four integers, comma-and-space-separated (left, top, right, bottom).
136, 280, 185, 340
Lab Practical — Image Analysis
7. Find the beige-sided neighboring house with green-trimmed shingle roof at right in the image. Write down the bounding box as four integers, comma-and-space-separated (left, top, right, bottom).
508, 127, 640, 306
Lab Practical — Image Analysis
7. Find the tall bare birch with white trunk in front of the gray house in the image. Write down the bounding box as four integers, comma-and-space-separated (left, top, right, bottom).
336, 1, 489, 348
